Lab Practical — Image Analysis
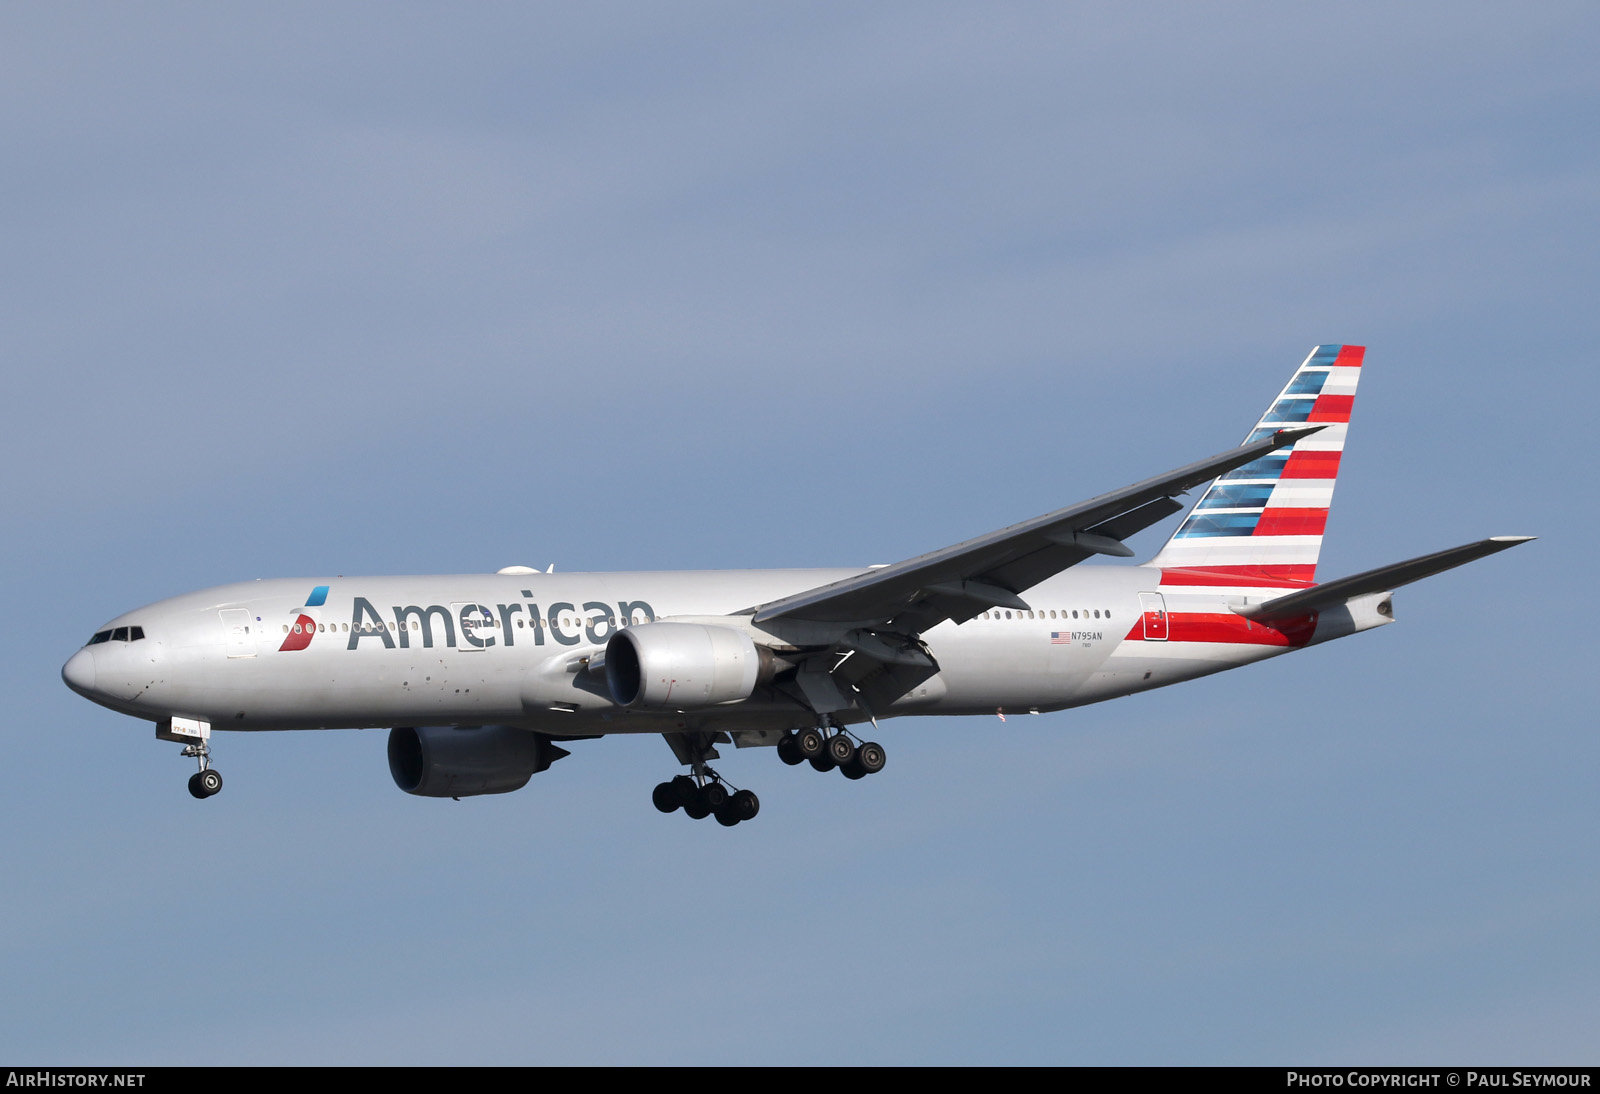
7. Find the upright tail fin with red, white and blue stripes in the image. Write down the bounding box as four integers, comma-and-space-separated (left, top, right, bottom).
1149, 345, 1366, 585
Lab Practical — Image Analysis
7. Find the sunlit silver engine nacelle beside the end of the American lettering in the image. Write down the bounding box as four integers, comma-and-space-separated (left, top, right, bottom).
605, 622, 773, 710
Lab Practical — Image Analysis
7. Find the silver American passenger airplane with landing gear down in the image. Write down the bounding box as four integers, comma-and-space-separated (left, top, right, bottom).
61, 345, 1533, 827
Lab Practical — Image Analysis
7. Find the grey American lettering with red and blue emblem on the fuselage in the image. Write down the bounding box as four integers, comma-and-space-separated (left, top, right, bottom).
278, 585, 656, 653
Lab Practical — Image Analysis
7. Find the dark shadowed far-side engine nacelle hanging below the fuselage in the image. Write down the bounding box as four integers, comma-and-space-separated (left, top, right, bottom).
389, 726, 571, 798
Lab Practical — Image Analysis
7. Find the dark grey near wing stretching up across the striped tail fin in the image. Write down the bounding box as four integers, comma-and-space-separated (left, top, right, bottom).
755, 425, 1322, 633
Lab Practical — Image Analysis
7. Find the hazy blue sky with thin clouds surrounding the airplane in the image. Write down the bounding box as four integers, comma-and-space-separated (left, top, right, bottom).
0, 3, 1600, 1064
